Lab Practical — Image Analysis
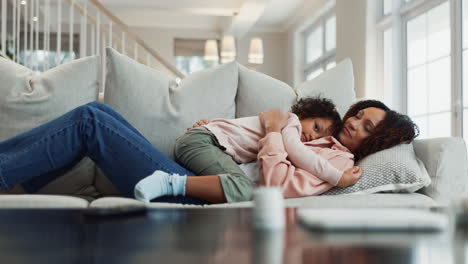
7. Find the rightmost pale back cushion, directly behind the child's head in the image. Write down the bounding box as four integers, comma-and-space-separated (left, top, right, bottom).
296, 59, 356, 117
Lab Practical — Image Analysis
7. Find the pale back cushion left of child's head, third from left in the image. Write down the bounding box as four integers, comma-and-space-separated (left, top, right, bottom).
236, 64, 296, 118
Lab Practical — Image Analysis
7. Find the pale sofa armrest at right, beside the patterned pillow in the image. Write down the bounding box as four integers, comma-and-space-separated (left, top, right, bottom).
413, 137, 468, 205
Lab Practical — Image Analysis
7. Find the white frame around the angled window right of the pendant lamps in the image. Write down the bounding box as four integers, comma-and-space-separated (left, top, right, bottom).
302, 7, 336, 80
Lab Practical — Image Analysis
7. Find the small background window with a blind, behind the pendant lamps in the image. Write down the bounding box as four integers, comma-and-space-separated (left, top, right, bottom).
174, 39, 219, 75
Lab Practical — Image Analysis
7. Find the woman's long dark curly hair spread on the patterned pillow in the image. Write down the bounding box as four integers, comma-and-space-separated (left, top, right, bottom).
343, 100, 419, 161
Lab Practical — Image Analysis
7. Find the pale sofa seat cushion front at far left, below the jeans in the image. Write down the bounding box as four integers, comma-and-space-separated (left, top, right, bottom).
0, 194, 89, 209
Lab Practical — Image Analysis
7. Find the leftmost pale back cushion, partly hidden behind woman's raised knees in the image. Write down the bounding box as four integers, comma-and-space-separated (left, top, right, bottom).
0, 57, 99, 195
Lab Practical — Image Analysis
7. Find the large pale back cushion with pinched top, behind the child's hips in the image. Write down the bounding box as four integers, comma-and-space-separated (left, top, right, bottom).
104, 48, 238, 157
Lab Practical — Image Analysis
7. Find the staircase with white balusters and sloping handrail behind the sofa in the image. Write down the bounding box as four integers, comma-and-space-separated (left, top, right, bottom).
0, 0, 184, 93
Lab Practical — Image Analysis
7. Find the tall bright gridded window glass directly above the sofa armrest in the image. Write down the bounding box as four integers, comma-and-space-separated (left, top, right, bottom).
406, 2, 452, 138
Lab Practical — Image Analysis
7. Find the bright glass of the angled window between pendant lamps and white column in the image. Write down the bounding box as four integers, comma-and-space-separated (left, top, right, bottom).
304, 12, 336, 80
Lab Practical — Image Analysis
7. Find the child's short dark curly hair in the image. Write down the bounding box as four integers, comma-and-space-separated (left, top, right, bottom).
291, 96, 343, 137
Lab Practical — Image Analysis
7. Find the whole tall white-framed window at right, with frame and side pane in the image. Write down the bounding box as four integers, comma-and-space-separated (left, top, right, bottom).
377, 0, 458, 142
